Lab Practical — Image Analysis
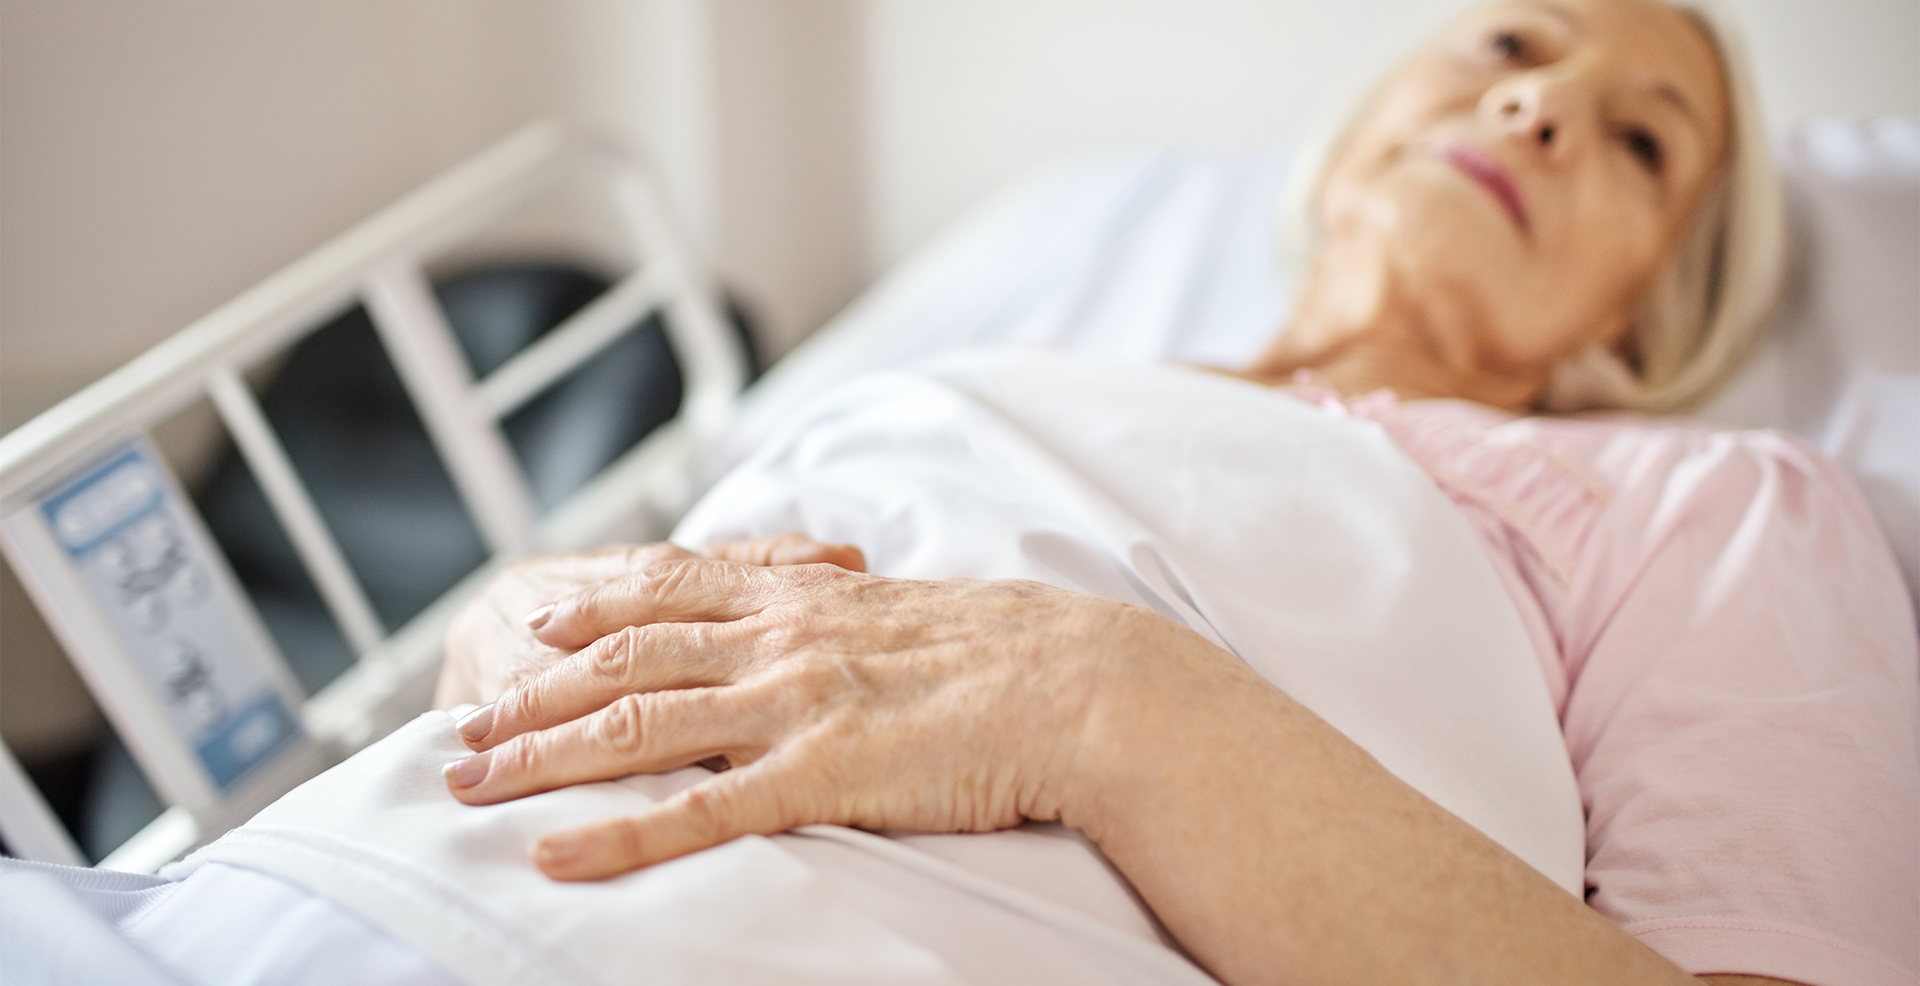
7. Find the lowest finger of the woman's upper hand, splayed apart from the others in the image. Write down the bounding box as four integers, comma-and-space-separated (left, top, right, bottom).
534, 758, 798, 880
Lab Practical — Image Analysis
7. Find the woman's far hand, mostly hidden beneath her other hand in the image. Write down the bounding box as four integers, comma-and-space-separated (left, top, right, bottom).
434, 533, 866, 708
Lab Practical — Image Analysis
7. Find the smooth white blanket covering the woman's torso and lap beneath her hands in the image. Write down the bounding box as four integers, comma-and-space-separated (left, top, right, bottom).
182, 353, 1584, 984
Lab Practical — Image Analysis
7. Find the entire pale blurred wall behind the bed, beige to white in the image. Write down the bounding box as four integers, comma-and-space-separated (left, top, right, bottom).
0, 0, 1920, 767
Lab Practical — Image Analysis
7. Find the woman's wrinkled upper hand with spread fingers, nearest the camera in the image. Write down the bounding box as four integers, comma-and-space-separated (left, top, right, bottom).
447, 556, 1265, 879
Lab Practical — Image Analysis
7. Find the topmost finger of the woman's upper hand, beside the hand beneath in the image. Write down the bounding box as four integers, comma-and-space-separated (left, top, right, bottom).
526, 558, 778, 650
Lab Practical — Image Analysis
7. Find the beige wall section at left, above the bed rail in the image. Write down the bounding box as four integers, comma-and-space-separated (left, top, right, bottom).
0, 0, 866, 428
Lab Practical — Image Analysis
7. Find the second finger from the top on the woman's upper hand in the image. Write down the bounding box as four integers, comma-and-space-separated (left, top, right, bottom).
459, 623, 755, 750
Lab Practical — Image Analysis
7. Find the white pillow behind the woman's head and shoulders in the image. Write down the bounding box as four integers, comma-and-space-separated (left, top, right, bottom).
725, 126, 1920, 610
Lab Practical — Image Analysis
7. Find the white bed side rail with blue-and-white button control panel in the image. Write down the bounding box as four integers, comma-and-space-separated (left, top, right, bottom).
0, 125, 749, 869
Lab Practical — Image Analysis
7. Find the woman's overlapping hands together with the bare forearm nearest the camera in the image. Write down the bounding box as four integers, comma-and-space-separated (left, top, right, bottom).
442, 537, 1761, 984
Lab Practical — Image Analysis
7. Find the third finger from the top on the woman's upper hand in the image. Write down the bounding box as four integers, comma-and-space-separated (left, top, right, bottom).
444, 689, 768, 804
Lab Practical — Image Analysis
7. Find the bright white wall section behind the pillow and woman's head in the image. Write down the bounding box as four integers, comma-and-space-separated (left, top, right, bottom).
868, 0, 1920, 270
